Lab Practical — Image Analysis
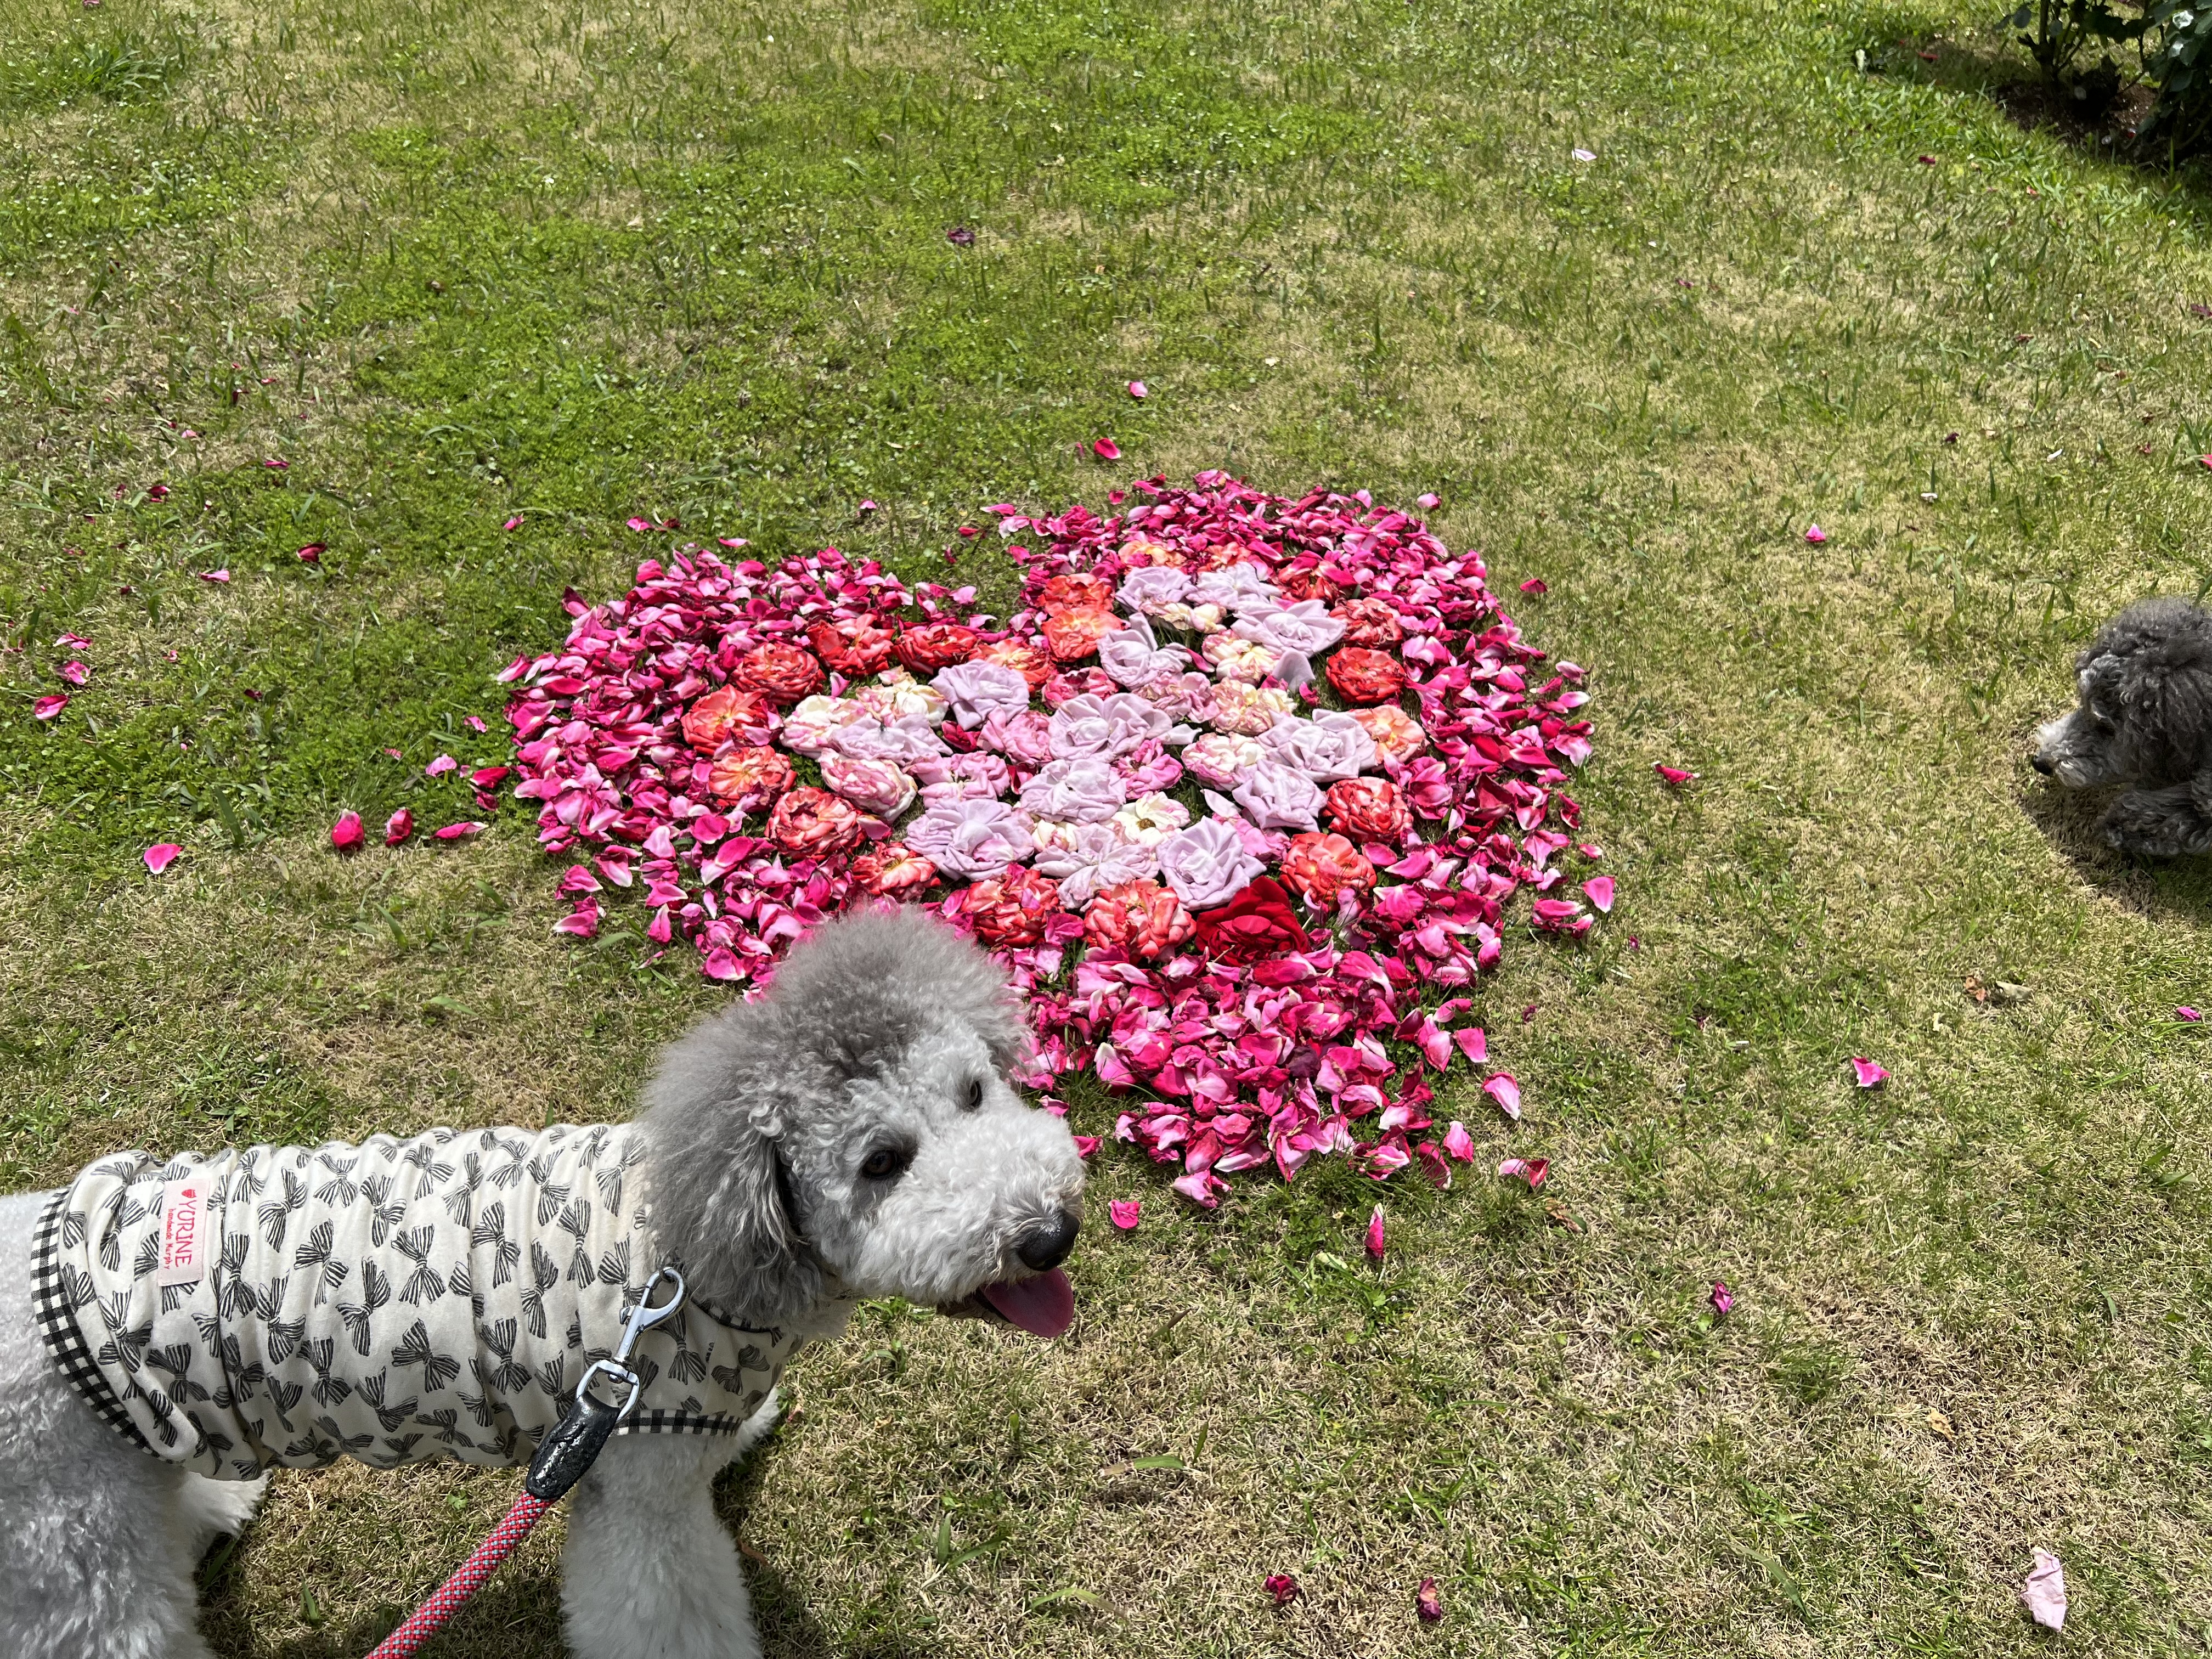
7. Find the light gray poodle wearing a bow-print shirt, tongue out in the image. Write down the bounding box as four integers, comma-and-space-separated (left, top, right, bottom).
0, 911, 1084, 1659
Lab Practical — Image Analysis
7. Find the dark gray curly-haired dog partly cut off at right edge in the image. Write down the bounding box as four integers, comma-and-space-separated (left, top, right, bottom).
2033, 600, 2212, 858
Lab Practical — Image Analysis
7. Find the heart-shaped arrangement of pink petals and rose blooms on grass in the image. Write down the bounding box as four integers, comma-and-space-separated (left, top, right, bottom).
502, 473, 1610, 1205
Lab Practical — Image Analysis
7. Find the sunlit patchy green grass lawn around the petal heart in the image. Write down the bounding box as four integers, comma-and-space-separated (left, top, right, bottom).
0, 0, 2212, 1659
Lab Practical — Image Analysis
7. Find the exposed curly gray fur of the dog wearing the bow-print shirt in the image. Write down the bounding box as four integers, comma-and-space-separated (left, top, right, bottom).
0, 911, 1084, 1659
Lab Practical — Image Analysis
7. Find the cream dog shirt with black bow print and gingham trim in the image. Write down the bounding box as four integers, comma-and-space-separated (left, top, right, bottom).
33, 1124, 801, 1480
